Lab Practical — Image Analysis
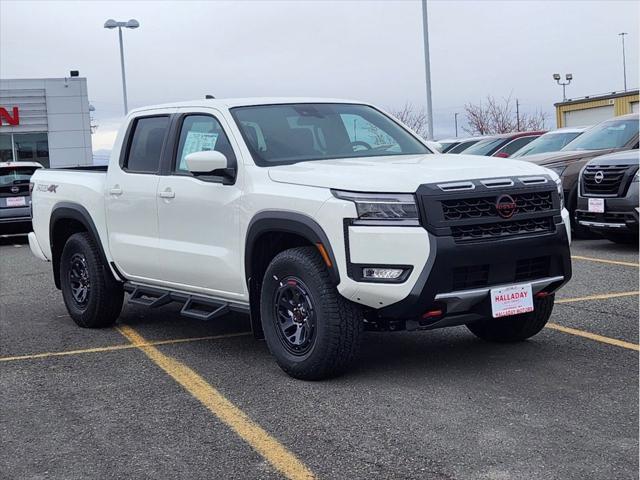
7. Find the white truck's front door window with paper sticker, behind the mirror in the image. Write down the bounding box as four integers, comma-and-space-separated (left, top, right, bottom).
175, 115, 236, 173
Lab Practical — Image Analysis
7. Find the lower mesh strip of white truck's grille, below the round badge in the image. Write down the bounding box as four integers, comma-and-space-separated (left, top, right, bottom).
451, 217, 553, 243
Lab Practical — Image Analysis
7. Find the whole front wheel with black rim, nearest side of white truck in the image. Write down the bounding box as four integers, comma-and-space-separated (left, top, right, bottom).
260, 247, 363, 380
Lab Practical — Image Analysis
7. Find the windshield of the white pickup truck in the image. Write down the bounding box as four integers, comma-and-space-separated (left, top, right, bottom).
231, 103, 431, 166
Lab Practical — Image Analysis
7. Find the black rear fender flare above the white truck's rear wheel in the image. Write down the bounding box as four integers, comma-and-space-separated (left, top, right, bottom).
49, 202, 116, 289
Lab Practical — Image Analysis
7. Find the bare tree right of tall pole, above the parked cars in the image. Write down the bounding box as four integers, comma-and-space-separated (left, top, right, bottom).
463, 95, 546, 135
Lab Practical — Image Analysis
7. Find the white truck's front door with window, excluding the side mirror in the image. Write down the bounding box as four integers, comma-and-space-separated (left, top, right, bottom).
157, 108, 245, 299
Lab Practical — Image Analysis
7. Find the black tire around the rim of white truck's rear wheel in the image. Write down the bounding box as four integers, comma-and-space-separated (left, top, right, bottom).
60, 232, 124, 328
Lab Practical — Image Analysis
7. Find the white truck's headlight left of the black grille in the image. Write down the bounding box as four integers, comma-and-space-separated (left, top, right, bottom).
331, 190, 419, 225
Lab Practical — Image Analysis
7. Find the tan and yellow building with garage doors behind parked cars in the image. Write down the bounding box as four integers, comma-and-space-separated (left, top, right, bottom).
555, 90, 639, 128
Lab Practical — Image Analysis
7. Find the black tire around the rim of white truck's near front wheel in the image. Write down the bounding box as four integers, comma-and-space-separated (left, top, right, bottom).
260, 247, 363, 380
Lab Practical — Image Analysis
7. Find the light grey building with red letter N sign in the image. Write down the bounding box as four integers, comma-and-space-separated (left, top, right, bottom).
0, 77, 93, 168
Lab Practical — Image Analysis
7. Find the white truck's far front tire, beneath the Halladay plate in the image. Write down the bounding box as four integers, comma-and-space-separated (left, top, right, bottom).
467, 295, 555, 343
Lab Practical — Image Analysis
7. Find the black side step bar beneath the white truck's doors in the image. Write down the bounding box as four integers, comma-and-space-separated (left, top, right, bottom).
124, 282, 249, 321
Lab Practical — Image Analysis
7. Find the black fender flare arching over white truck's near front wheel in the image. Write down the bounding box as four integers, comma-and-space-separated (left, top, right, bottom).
244, 210, 340, 285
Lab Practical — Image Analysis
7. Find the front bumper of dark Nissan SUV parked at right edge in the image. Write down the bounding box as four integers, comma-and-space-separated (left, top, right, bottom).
576, 182, 638, 234
